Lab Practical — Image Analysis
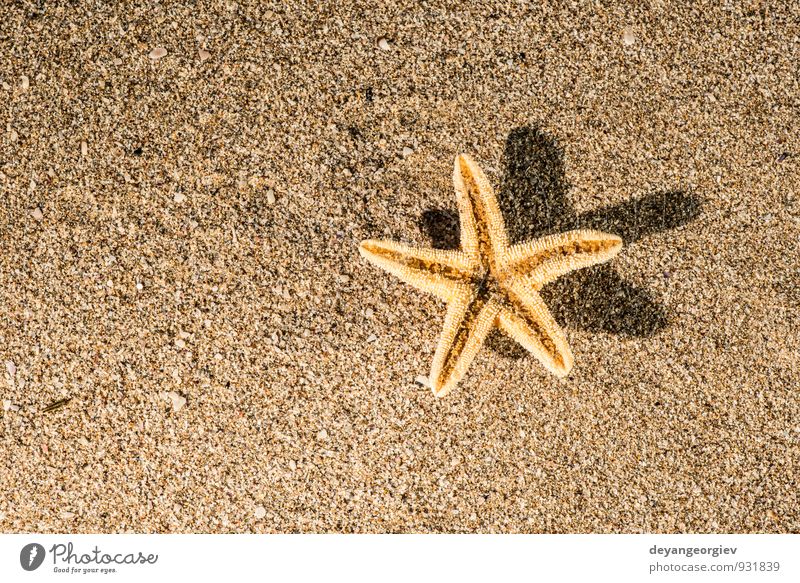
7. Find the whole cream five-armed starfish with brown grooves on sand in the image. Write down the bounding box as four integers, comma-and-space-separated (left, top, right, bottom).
359, 154, 622, 397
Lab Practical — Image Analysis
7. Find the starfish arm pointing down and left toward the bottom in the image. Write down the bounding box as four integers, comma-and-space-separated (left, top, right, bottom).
430, 289, 500, 397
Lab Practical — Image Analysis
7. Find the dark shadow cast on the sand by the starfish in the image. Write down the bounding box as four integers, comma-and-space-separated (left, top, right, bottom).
419, 126, 702, 358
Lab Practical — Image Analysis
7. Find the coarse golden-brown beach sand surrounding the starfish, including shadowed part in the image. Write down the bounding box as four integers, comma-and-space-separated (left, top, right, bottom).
0, 1, 800, 533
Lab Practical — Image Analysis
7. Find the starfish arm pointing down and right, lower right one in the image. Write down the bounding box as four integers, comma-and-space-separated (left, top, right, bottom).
497, 282, 573, 377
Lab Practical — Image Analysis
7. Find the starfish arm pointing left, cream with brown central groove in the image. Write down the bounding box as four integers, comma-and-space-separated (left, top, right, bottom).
358, 240, 472, 301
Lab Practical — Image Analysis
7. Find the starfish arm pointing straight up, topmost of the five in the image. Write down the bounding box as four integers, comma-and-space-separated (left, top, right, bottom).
453, 154, 508, 262
